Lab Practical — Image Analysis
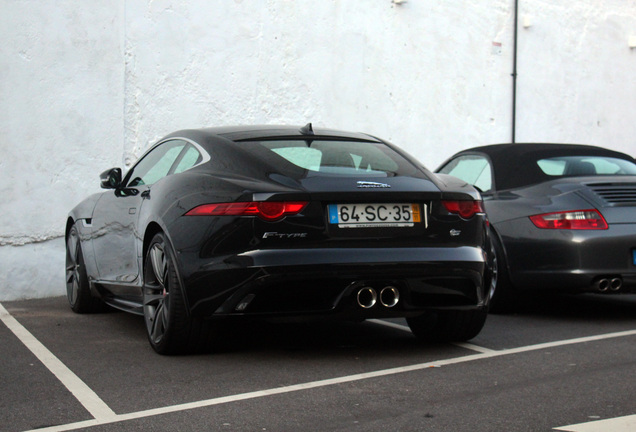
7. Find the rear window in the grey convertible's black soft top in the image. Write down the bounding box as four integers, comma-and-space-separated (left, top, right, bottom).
537, 156, 636, 177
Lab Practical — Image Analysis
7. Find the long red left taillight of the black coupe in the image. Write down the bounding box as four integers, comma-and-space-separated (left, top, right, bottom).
186, 201, 307, 221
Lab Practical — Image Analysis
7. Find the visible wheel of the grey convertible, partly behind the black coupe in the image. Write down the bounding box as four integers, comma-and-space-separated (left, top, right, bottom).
488, 230, 519, 314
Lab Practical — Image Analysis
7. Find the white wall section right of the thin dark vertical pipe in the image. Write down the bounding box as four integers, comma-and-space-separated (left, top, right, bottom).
517, 0, 636, 147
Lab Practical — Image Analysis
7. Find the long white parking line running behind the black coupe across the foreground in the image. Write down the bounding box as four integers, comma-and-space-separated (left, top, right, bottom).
6, 305, 636, 432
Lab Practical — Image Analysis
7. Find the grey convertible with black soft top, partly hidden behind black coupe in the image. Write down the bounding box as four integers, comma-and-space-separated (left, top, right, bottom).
437, 144, 636, 312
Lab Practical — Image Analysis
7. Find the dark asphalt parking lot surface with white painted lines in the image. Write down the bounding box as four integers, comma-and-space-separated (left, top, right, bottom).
0, 295, 636, 432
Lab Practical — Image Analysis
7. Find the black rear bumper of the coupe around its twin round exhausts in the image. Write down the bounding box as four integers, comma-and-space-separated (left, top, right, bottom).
181, 247, 486, 319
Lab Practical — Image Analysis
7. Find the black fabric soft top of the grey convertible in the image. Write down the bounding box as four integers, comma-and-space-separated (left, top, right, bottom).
444, 143, 636, 190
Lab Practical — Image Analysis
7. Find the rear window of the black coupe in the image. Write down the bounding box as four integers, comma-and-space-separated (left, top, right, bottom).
259, 140, 413, 176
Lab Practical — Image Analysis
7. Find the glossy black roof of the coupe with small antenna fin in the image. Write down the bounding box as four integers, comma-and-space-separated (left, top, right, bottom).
168, 123, 382, 142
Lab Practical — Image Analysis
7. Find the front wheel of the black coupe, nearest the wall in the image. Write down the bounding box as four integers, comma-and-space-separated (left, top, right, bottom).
66, 225, 104, 313
